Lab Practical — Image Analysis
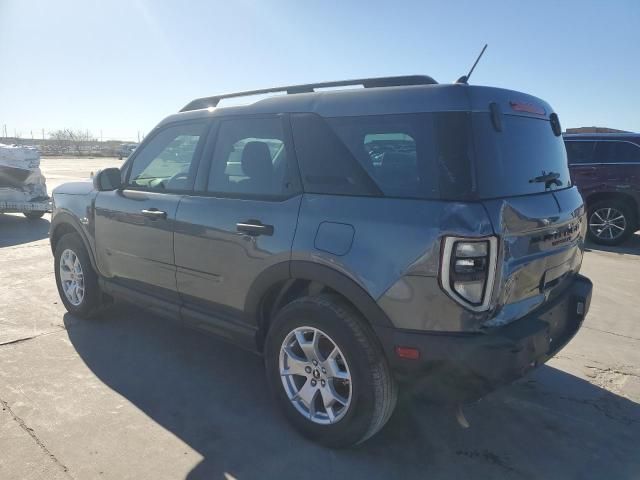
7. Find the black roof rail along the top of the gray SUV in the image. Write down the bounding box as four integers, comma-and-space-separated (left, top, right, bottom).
180, 75, 438, 112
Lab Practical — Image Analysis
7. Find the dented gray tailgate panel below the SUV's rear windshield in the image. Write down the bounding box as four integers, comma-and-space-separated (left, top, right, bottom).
483, 187, 586, 326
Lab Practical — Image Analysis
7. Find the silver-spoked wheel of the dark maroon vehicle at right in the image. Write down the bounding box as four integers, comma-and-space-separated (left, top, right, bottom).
587, 199, 637, 246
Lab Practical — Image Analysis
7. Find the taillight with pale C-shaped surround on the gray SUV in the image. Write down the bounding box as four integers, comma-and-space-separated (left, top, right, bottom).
440, 237, 498, 312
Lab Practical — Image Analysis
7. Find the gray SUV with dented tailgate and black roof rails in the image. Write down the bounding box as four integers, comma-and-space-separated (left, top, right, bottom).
50, 76, 591, 447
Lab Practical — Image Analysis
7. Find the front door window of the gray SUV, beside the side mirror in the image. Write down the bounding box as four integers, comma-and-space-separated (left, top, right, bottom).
128, 123, 207, 191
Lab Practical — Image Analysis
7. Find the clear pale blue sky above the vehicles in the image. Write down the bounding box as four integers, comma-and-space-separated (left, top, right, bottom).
0, 0, 640, 139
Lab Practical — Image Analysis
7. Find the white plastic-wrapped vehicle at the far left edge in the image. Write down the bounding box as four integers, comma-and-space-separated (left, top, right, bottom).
0, 143, 47, 202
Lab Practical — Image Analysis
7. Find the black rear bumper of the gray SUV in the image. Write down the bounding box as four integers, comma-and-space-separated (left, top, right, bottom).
376, 275, 592, 402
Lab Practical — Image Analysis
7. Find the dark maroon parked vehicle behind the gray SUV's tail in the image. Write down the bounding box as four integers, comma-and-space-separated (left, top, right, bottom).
564, 133, 640, 245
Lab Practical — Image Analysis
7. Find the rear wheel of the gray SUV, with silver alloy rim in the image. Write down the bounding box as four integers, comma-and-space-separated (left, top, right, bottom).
265, 295, 397, 448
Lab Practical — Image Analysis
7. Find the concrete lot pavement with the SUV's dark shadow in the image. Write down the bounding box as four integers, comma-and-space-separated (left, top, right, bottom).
0, 159, 640, 480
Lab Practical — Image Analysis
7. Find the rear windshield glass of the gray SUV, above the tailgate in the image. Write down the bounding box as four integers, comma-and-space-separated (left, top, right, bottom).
472, 113, 571, 198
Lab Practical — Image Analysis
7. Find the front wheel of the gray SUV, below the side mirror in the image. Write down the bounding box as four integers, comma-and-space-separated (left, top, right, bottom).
54, 233, 100, 318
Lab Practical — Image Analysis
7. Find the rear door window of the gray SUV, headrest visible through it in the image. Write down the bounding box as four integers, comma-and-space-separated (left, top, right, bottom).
207, 117, 288, 196
